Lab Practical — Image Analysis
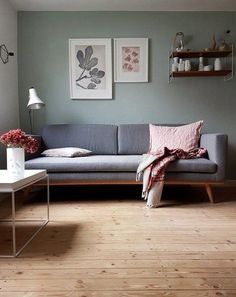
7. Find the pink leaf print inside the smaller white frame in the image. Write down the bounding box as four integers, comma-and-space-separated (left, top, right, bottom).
122, 46, 140, 72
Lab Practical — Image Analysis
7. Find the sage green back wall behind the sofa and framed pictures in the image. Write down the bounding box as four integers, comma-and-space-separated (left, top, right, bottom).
18, 12, 236, 179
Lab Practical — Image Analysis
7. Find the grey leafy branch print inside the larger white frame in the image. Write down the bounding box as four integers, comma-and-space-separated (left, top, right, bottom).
76, 45, 105, 90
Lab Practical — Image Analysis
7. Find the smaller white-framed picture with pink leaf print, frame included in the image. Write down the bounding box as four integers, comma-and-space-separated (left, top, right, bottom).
114, 38, 148, 82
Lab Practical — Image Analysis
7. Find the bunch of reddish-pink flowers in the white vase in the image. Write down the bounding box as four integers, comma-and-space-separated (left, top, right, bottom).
0, 129, 39, 153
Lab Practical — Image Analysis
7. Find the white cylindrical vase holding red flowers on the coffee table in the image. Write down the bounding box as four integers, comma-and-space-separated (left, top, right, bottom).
7, 147, 25, 177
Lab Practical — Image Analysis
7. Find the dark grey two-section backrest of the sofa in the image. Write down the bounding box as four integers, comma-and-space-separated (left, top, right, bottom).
41, 124, 188, 155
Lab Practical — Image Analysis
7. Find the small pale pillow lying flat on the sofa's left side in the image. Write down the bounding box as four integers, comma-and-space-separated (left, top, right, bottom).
42, 147, 92, 158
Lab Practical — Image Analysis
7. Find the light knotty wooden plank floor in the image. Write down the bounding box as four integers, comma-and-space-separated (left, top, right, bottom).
0, 187, 236, 297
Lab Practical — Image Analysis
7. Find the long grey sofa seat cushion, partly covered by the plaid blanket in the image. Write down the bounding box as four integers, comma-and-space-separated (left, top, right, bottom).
25, 155, 217, 173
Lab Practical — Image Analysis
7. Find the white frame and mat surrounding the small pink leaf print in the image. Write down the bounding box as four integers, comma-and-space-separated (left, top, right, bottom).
114, 38, 148, 82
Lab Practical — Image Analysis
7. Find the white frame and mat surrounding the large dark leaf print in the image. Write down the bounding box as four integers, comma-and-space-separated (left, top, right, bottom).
69, 38, 112, 100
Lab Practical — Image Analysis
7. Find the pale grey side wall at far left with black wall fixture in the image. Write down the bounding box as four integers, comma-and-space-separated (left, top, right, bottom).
0, 0, 19, 169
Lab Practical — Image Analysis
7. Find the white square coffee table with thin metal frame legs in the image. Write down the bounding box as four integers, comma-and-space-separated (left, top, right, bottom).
0, 170, 49, 258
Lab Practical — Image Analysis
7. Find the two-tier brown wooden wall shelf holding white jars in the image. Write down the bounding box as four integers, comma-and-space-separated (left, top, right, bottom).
169, 45, 233, 82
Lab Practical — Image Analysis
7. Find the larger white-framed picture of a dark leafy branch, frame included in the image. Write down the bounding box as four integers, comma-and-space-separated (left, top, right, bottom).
69, 38, 112, 99
